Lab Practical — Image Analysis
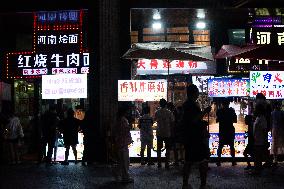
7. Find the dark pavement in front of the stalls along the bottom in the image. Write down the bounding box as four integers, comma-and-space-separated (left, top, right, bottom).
0, 161, 284, 189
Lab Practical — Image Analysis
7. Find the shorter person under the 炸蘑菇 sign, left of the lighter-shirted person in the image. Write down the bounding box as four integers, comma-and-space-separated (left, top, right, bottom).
138, 106, 154, 165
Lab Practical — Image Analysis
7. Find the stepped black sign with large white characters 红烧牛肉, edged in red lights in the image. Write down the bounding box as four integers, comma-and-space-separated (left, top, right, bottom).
6, 11, 89, 78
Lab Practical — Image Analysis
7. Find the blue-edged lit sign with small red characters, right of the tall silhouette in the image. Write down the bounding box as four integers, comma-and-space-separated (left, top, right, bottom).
208, 78, 249, 97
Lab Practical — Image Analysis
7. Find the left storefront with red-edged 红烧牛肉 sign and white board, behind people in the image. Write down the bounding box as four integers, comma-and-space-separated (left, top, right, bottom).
5, 10, 89, 160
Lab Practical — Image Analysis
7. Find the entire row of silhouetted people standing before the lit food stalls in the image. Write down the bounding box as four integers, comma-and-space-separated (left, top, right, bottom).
1, 84, 284, 188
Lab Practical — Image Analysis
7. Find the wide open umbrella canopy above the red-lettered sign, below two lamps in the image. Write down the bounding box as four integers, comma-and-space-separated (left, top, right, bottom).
122, 42, 214, 61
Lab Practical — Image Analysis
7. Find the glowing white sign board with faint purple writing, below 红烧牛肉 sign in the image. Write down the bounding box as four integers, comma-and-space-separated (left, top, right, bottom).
42, 74, 87, 99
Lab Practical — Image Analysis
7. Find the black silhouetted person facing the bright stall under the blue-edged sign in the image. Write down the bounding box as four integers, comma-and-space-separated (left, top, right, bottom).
216, 99, 237, 166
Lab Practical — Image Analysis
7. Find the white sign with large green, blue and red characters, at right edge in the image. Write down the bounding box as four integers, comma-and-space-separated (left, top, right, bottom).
250, 71, 284, 99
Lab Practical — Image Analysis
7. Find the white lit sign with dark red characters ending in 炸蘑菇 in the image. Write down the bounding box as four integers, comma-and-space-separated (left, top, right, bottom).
118, 80, 167, 101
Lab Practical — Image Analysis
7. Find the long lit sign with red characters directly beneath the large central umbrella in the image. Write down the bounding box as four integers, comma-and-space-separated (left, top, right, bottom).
136, 59, 216, 75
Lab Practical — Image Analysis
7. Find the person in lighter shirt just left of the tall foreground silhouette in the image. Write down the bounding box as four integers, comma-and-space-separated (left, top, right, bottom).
155, 99, 174, 169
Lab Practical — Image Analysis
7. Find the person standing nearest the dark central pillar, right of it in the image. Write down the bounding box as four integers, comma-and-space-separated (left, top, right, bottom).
114, 105, 134, 183
